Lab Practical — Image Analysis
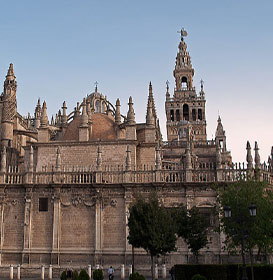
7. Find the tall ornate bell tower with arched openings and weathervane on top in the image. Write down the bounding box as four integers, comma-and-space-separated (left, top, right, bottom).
165, 28, 207, 141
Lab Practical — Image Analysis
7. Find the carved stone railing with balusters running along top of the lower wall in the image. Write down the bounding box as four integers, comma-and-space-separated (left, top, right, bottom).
0, 165, 273, 185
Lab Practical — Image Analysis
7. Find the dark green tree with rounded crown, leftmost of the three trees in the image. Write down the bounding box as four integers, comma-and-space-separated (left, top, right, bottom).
128, 193, 176, 279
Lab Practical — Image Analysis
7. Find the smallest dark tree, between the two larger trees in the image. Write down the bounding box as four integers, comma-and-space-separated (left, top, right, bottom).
175, 205, 208, 262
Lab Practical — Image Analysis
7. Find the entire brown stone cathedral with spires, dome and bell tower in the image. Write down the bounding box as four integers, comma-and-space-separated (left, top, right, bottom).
0, 31, 273, 266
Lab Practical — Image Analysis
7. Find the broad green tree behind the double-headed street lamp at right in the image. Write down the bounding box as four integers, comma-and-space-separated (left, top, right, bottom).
218, 178, 273, 272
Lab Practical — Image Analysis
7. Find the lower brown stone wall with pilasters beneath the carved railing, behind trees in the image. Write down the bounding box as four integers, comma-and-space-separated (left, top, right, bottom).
0, 183, 221, 266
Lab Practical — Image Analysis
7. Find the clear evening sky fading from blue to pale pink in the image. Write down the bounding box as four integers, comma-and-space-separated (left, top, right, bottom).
0, 0, 273, 162
